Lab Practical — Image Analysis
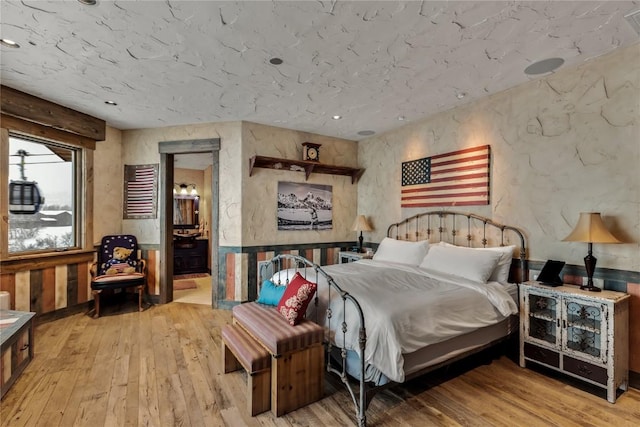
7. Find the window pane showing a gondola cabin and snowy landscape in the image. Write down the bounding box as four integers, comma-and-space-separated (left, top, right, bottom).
8, 133, 82, 254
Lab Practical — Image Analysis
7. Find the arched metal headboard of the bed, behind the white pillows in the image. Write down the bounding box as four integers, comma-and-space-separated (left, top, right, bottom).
387, 211, 527, 283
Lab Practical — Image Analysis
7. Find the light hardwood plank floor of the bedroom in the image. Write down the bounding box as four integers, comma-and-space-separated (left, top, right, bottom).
0, 303, 640, 427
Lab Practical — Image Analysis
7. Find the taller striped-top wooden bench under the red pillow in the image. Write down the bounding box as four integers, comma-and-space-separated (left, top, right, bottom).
232, 302, 324, 417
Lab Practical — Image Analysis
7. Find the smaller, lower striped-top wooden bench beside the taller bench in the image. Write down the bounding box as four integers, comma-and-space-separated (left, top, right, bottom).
222, 325, 271, 417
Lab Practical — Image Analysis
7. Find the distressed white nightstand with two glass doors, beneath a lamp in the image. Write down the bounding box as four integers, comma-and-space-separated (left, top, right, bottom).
520, 282, 630, 403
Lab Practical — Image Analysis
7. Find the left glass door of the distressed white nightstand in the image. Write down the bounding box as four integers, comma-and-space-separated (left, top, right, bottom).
525, 292, 560, 347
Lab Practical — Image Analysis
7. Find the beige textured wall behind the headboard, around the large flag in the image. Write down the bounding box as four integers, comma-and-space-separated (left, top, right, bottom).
358, 44, 640, 271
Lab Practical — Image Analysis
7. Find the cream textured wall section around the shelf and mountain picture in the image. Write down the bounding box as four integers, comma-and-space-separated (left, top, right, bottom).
242, 122, 366, 246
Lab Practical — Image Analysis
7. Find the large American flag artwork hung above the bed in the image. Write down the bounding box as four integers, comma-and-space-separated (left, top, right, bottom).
400, 145, 491, 208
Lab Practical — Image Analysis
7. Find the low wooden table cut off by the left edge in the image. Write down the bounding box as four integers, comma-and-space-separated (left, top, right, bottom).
0, 310, 35, 398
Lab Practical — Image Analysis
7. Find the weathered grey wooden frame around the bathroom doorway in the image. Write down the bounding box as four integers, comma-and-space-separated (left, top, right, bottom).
158, 138, 220, 308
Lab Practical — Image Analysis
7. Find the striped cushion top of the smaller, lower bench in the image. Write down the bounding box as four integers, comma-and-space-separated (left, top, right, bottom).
222, 325, 271, 374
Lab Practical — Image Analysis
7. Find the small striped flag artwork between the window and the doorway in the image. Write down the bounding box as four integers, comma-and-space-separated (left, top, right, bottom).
124, 165, 158, 219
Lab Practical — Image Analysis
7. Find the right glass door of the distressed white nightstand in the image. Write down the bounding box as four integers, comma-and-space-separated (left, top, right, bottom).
562, 299, 607, 361
